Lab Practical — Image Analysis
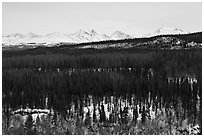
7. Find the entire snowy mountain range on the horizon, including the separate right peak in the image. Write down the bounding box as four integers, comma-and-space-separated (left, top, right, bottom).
2, 27, 189, 46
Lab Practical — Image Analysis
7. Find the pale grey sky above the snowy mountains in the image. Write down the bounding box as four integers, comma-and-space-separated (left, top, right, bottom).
2, 2, 202, 36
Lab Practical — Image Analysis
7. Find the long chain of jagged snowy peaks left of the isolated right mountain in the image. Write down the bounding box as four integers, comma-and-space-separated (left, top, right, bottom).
2, 30, 131, 46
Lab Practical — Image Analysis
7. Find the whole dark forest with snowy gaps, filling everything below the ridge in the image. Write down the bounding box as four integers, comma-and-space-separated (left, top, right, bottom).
2, 47, 202, 134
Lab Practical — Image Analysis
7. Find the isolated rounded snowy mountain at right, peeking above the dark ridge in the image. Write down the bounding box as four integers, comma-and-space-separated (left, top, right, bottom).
144, 27, 187, 37
